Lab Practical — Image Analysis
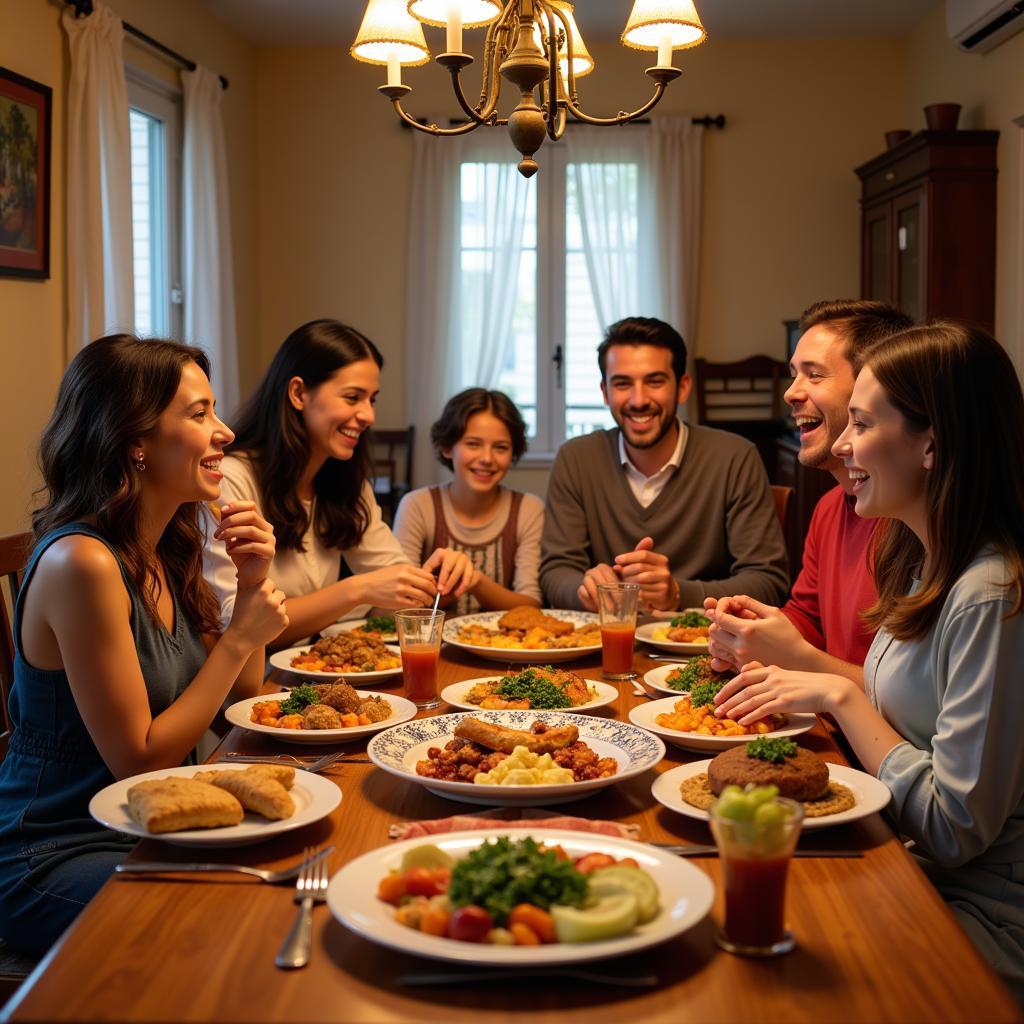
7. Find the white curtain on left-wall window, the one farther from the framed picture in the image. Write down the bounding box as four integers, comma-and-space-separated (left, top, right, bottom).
181, 67, 240, 416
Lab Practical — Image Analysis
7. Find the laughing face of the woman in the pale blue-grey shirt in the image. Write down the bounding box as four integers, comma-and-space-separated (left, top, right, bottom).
833, 367, 934, 545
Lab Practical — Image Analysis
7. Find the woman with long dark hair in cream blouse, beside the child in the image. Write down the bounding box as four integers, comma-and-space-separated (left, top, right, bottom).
204, 319, 473, 647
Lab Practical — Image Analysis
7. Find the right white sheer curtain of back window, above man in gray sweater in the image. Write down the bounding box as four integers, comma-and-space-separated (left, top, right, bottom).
564, 117, 703, 342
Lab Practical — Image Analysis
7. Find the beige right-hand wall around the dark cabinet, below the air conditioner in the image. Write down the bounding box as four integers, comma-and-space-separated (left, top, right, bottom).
896, 7, 1024, 352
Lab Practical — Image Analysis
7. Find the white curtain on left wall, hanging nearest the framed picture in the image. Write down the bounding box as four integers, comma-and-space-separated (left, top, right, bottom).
61, 3, 135, 353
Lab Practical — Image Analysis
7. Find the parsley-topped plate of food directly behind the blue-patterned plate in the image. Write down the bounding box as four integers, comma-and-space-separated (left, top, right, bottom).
441, 665, 618, 712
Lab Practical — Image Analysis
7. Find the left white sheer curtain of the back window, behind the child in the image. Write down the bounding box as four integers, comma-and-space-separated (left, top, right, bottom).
406, 129, 529, 485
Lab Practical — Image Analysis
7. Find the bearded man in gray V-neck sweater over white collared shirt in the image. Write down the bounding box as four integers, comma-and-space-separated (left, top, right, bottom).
541, 316, 788, 611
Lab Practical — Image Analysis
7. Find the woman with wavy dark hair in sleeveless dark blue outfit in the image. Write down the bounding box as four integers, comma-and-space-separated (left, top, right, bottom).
0, 335, 288, 953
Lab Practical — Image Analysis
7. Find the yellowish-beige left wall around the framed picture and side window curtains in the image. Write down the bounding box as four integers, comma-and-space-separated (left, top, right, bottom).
0, 0, 254, 534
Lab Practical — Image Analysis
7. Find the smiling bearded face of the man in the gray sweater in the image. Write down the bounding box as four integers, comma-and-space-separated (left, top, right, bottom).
601, 344, 690, 449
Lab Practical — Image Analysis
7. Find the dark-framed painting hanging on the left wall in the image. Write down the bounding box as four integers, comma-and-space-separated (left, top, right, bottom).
0, 68, 52, 278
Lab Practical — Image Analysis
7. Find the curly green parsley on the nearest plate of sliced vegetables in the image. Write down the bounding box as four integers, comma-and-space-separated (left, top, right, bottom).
447, 836, 587, 927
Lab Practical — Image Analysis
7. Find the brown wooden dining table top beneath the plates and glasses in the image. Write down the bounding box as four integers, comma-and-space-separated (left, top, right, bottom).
4, 645, 1022, 1024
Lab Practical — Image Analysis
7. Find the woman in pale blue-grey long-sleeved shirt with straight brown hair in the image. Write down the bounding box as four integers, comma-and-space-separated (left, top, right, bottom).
717, 322, 1024, 999
